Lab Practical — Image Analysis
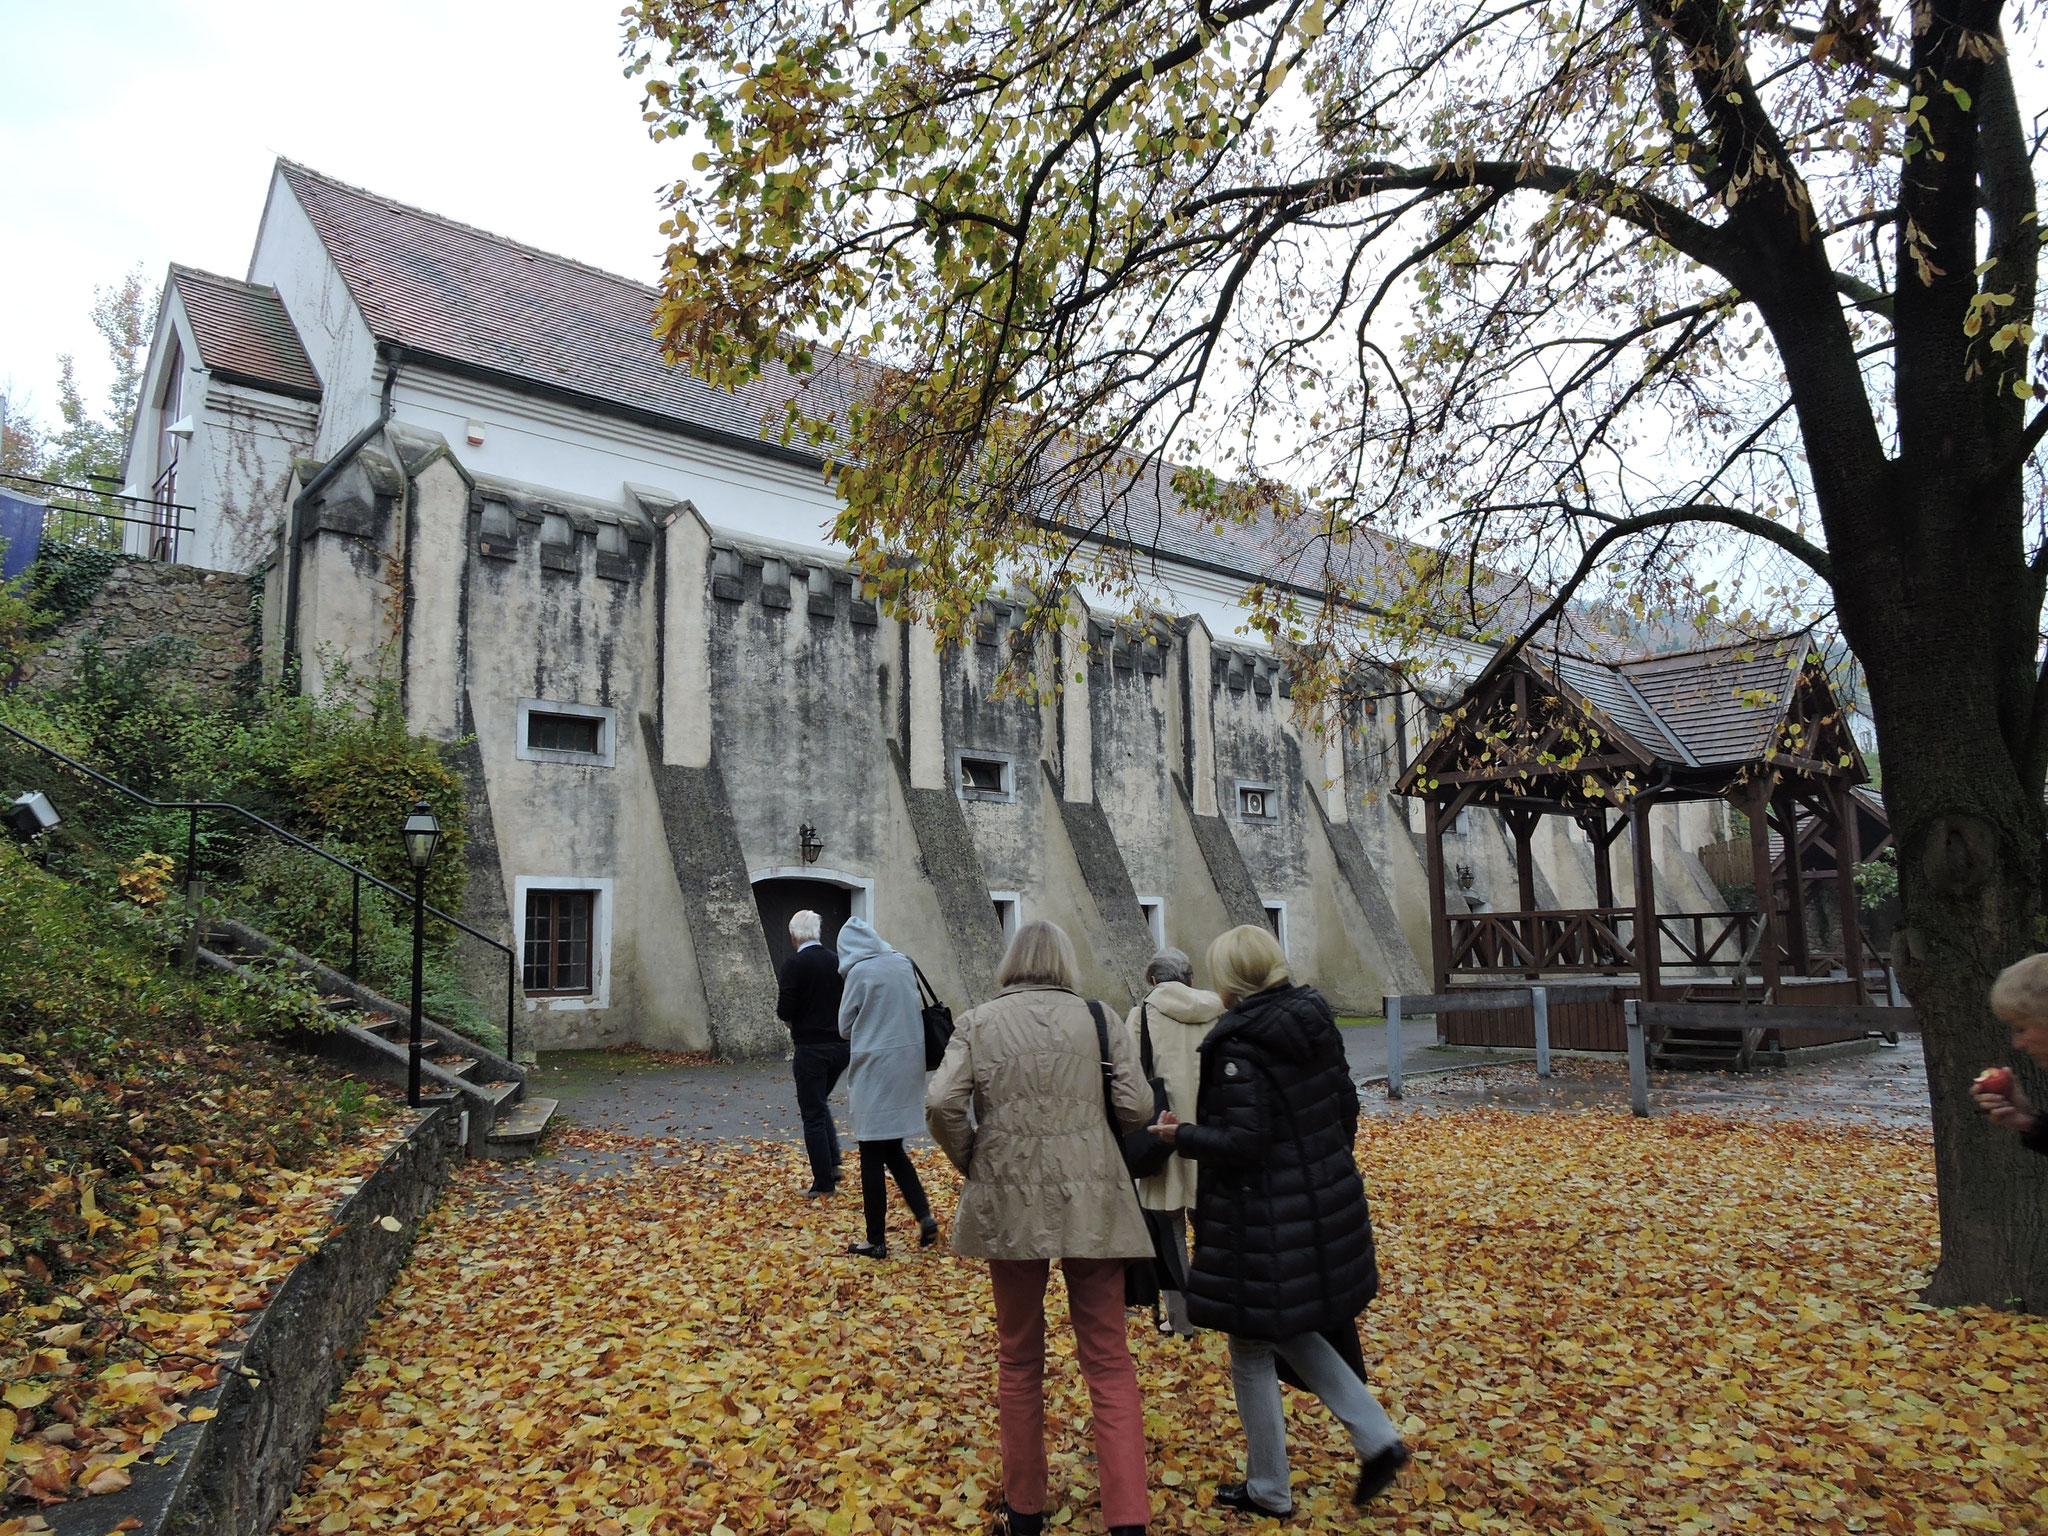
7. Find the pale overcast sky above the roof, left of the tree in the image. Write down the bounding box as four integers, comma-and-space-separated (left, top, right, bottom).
0, 0, 686, 434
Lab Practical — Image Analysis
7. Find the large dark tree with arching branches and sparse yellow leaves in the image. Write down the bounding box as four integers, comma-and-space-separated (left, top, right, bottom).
627, 0, 2048, 1311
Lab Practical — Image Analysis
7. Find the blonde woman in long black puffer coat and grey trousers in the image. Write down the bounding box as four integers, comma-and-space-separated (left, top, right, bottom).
1153, 926, 1409, 1516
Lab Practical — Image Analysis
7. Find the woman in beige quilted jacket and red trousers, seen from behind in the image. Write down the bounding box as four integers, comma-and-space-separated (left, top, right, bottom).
924, 922, 1151, 1536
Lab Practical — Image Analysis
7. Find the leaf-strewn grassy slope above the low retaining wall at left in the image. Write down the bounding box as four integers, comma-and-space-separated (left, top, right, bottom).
0, 846, 401, 1507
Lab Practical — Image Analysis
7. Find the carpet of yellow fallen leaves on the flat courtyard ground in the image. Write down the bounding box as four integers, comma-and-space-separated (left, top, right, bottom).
283, 1110, 2048, 1536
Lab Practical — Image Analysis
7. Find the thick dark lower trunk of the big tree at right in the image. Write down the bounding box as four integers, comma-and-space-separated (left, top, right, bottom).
1851, 626, 2048, 1313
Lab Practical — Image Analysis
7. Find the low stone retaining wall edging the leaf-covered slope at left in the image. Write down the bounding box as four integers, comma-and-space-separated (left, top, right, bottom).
43, 1106, 461, 1536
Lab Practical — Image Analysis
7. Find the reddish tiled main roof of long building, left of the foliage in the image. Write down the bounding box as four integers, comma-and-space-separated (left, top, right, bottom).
279, 160, 852, 457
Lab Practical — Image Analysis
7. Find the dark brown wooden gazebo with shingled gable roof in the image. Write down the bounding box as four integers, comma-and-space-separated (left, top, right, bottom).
1397, 635, 1868, 1049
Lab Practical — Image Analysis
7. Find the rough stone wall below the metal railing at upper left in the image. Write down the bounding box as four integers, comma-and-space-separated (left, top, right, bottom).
29, 559, 260, 694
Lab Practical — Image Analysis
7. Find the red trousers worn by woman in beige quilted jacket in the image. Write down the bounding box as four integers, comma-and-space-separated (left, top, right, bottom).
989, 1260, 1151, 1526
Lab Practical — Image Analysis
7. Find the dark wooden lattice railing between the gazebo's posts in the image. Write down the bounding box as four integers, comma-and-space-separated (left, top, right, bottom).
1448, 907, 1785, 975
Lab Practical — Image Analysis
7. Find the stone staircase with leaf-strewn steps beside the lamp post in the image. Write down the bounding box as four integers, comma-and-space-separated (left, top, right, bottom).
199, 918, 557, 1157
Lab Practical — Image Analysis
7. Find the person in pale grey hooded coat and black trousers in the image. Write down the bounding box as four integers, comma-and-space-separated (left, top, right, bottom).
840, 918, 938, 1260
